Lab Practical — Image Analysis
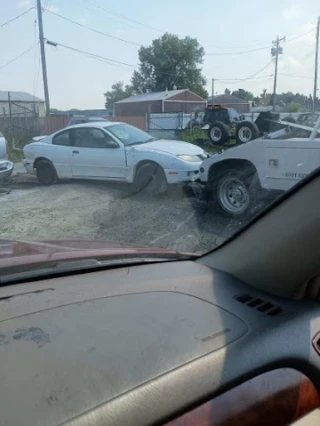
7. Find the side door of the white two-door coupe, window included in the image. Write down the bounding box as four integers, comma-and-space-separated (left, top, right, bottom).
71, 126, 126, 179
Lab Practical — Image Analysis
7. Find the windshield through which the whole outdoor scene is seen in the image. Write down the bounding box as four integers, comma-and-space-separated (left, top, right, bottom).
0, 0, 320, 280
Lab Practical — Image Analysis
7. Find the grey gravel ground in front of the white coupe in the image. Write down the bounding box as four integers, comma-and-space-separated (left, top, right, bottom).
0, 168, 245, 252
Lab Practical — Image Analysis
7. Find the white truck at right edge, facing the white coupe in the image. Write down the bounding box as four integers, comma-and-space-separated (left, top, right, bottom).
200, 116, 320, 218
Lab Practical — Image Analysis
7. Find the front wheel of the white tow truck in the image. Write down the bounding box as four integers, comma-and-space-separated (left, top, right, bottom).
208, 169, 259, 219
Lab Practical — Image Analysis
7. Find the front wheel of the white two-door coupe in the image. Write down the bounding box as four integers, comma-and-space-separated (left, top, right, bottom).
133, 162, 168, 195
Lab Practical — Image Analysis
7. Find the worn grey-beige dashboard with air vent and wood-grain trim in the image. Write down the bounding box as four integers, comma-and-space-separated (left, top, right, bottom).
0, 261, 320, 426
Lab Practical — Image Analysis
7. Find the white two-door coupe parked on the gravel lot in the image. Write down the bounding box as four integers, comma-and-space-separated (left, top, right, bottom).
23, 122, 208, 192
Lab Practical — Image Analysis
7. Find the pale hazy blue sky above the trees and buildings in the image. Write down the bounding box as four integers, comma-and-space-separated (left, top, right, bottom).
0, 0, 320, 109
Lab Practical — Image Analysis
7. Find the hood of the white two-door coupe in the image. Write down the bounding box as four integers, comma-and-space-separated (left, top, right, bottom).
132, 139, 204, 156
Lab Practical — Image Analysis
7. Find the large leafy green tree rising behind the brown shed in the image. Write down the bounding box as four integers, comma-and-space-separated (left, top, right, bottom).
131, 33, 208, 98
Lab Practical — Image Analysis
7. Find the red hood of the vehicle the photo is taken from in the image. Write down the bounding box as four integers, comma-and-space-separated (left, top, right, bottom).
0, 239, 194, 268
